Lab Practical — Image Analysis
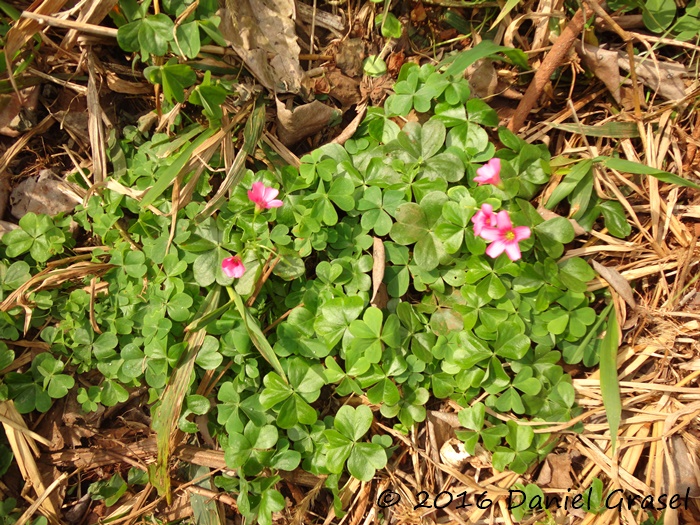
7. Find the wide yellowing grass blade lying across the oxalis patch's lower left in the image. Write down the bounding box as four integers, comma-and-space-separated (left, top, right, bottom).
149, 286, 221, 504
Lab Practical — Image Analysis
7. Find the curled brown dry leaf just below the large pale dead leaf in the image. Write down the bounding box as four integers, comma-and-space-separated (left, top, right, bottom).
276, 99, 340, 146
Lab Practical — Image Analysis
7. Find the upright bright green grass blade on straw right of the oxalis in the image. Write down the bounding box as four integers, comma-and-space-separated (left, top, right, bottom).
600, 308, 622, 451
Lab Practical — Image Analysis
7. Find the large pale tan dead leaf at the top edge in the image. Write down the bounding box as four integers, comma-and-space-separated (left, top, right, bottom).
220, 0, 304, 93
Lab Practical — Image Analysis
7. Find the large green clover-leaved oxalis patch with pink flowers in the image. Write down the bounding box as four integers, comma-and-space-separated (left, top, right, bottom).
0, 58, 620, 524
